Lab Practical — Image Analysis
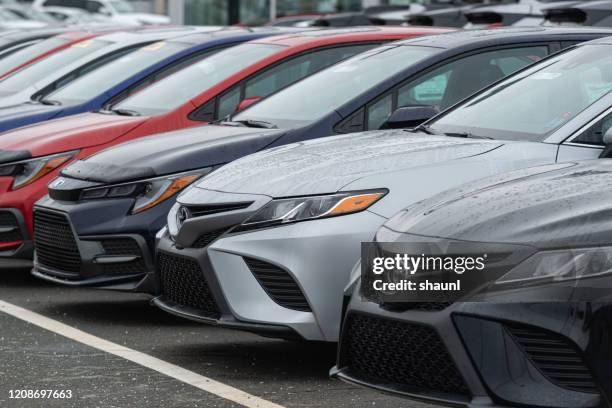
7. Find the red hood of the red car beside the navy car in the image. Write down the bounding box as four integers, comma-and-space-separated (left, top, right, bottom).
0, 113, 148, 157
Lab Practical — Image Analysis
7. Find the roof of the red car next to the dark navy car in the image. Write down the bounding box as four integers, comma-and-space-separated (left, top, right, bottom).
253, 26, 455, 47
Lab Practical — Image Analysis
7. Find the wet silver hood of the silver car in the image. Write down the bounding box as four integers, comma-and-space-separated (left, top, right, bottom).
198, 130, 500, 197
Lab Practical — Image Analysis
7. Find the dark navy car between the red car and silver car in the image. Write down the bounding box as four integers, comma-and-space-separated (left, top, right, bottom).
33, 28, 610, 292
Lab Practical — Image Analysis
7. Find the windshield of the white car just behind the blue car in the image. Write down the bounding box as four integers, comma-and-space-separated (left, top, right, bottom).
0, 40, 112, 96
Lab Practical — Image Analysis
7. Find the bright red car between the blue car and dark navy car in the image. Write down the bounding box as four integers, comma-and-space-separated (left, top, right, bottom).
0, 27, 451, 267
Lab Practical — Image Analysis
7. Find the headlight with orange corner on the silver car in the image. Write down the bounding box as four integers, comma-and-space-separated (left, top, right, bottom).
234, 190, 388, 231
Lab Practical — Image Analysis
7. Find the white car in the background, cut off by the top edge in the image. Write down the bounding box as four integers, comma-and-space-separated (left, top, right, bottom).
32, 0, 170, 25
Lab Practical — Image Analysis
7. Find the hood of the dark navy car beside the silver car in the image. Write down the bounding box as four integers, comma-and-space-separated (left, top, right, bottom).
62, 125, 285, 183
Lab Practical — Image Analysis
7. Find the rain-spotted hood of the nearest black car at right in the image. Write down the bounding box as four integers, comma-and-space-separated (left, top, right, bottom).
385, 159, 612, 248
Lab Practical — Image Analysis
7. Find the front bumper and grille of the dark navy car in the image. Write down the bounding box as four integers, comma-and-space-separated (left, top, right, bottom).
32, 197, 171, 293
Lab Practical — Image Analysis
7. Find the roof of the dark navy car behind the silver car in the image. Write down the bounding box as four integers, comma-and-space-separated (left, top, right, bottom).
395, 27, 612, 49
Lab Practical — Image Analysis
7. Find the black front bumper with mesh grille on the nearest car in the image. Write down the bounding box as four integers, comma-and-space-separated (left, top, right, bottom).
330, 282, 612, 408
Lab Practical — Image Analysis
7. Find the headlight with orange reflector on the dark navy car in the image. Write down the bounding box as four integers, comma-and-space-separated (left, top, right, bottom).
81, 167, 212, 214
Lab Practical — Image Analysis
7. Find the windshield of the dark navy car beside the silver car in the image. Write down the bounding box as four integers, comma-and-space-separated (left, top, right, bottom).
232, 45, 438, 127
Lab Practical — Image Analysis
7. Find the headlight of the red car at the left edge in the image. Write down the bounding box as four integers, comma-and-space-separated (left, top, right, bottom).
0, 151, 78, 190
